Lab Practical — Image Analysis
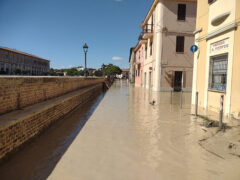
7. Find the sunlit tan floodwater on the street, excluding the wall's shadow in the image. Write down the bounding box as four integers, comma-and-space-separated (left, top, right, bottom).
49, 81, 240, 180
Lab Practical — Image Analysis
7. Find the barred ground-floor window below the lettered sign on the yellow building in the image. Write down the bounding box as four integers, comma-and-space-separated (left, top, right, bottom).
209, 54, 228, 92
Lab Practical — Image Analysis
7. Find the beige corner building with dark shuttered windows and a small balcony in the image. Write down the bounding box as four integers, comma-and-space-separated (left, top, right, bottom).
139, 0, 197, 91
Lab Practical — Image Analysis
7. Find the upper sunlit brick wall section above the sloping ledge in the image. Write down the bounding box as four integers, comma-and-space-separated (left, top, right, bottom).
0, 76, 104, 115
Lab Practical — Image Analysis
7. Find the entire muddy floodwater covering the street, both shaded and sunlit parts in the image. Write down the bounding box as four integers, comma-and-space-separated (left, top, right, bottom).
0, 81, 240, 180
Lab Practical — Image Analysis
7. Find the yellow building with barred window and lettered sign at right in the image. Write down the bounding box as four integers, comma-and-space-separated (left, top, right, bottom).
192, 0, 240, 117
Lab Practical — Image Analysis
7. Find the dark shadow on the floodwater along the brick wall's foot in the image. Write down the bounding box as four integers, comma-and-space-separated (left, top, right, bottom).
0, 92, 105, 180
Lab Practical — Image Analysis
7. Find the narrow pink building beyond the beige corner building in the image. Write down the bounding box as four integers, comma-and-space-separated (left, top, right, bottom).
134, 40, 146, 86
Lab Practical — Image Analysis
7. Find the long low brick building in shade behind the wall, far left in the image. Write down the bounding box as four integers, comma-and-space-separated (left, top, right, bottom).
0, 47, 50, 75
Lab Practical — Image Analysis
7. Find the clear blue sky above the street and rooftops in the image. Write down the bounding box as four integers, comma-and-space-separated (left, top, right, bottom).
0, 0, 152, 68
